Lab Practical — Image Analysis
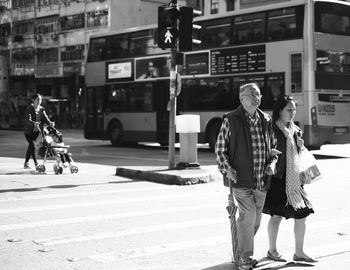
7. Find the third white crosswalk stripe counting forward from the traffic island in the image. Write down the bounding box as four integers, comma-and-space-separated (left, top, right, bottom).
0, 204, 222, 231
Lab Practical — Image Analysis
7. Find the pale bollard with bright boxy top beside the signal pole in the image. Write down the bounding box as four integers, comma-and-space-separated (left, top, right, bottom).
176, 114, 200, 168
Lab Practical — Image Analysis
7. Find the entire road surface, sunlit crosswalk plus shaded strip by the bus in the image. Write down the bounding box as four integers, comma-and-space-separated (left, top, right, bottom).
0, 131, 350, 270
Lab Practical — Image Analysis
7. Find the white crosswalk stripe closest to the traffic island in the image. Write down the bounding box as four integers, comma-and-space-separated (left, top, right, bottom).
0, 184, 178, 202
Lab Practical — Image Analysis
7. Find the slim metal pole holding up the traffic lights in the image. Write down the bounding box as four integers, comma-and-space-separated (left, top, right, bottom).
169, 48, 176, 169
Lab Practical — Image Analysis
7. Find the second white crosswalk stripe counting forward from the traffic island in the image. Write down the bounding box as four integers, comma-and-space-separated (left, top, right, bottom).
0, 191, 223, 214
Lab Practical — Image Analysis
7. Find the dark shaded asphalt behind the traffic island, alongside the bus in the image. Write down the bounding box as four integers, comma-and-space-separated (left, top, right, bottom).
0, 130, 215, 166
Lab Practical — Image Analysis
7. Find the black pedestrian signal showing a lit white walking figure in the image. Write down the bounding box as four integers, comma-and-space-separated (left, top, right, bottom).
158, 6, 179, 50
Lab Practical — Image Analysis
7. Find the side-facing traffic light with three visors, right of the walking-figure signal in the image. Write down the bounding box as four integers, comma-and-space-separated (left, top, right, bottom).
179, 7, 201, 51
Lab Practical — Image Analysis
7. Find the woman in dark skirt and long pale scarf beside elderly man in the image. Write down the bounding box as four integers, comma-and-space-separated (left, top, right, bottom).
263, 95, 316, 263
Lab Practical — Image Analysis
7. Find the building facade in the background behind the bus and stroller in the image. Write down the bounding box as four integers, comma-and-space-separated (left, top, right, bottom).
0, 0, 308, 128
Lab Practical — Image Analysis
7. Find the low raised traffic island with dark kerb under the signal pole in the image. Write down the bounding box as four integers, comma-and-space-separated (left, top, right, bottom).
115, 166, 222, 185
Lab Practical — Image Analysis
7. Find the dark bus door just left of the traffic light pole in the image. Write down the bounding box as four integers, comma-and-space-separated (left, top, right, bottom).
154, 81, 169, 145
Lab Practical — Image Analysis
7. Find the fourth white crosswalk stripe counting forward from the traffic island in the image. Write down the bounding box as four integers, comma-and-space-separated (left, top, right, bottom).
33, 216, 227, 246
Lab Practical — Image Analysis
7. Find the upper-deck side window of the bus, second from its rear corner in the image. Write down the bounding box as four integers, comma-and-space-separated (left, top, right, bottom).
233, 13, 265, 44
